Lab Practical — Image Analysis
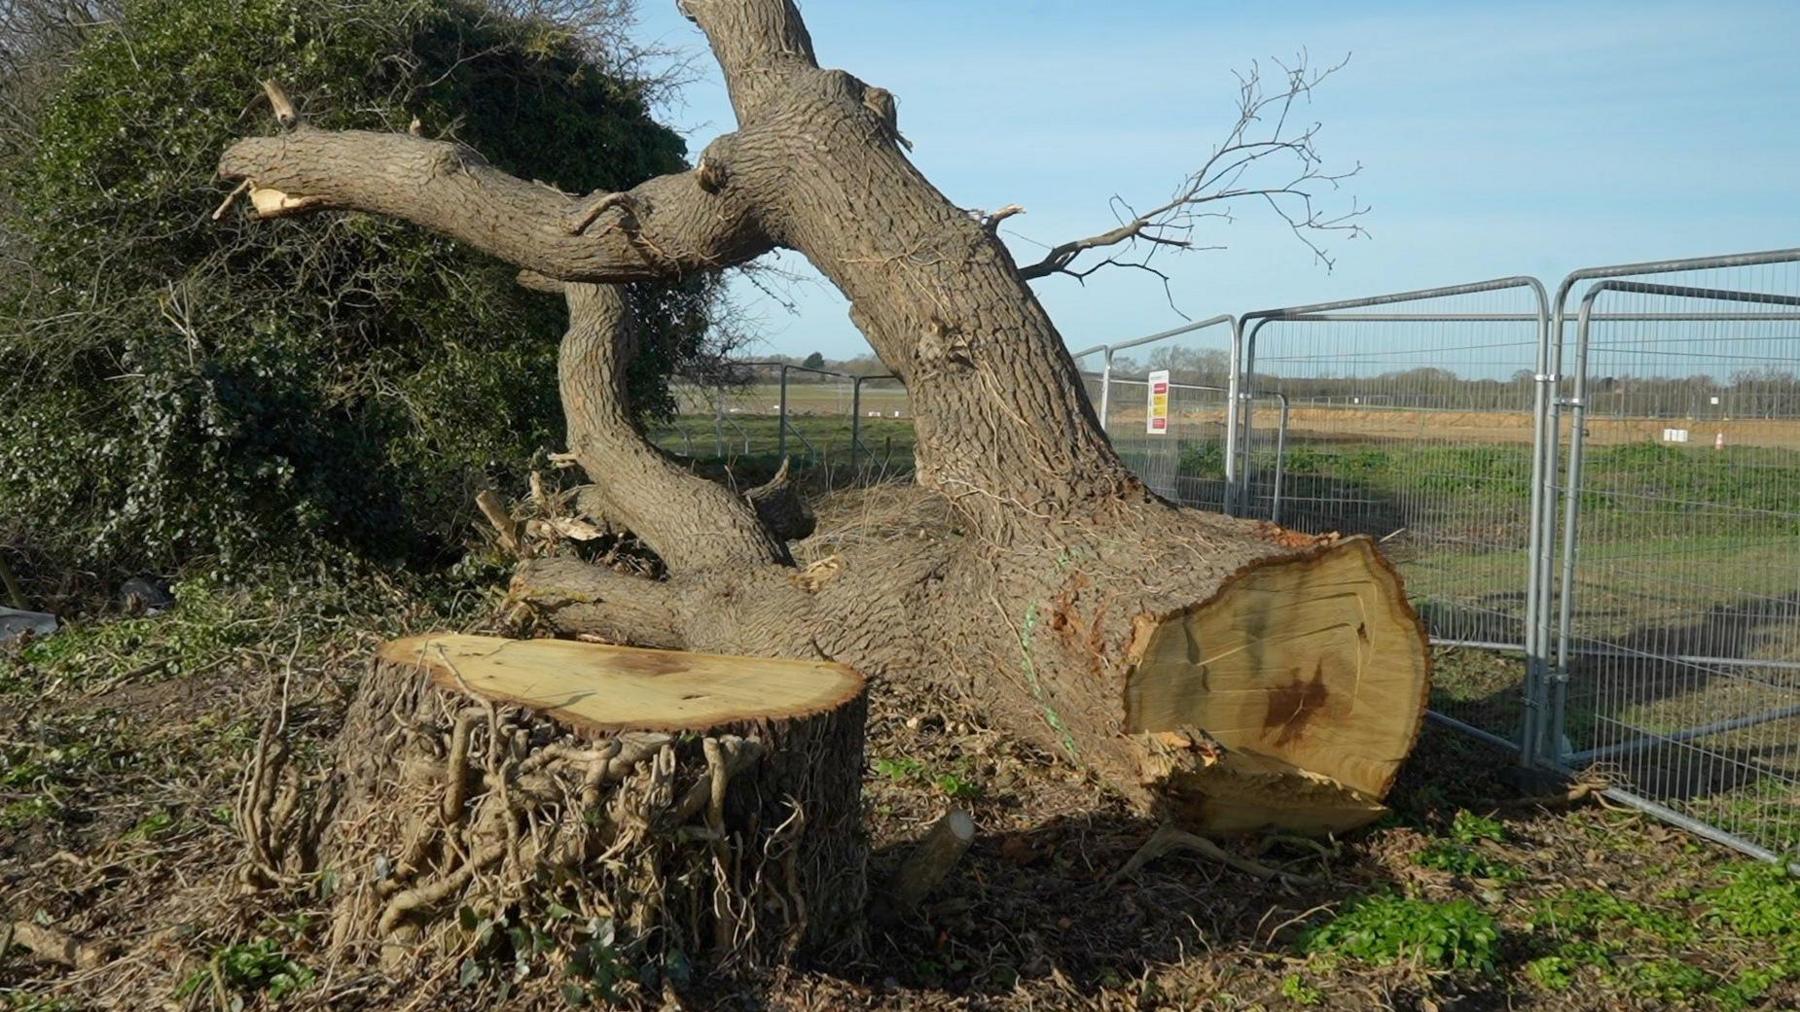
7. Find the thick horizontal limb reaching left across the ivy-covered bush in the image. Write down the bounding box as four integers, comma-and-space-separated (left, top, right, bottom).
220, 126, 772, 283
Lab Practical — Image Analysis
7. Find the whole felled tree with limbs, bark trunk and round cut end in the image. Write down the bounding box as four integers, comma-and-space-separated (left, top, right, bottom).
220, 0, 1427, 830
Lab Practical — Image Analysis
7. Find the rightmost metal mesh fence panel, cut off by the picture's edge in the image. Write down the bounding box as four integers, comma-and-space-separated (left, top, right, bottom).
1544, 250, 1800, 857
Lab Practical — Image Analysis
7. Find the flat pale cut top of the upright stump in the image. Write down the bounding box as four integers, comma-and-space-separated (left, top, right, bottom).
380, 634, 862, 733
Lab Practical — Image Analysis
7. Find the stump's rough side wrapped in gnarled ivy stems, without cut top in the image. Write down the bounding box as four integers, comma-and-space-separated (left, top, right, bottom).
239, 644, 866, 972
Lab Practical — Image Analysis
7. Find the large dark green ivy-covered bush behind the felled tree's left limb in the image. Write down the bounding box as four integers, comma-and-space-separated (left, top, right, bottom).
0, 0, 711, 574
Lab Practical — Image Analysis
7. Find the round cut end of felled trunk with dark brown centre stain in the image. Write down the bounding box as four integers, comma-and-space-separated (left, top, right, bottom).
1125, 538, 1431, 832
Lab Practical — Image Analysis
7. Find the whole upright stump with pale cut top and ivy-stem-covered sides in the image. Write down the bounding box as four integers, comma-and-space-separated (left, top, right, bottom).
306, 634, 868, 971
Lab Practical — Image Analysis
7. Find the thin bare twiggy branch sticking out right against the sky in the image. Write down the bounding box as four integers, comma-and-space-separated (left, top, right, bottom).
1019, 52, 1368, 283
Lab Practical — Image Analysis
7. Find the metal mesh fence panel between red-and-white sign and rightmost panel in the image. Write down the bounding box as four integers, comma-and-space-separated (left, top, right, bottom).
1238, 277, 1546, 744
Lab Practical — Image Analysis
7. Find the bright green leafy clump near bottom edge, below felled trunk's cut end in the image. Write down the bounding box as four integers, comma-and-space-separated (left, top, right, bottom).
1301, 893, 1499, 972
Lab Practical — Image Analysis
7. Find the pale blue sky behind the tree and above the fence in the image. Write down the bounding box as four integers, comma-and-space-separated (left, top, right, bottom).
637, 0, 1800, 358
